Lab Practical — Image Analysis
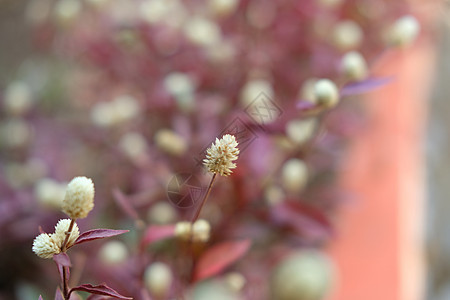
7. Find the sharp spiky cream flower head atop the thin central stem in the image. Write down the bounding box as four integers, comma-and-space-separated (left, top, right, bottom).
203, 134, 239, 176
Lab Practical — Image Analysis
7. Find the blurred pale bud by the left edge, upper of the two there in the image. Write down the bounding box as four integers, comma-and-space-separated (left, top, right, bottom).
3, 81, 33, 116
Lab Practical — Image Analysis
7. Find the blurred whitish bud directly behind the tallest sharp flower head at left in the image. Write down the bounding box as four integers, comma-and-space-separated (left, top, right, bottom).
34, 178, 67, 210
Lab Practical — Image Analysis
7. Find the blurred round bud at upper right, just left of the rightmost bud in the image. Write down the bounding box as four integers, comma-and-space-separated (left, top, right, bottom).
333, 20, 364, 51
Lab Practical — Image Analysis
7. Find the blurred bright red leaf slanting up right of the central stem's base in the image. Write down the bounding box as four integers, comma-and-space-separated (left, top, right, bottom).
194, 239, 251, 281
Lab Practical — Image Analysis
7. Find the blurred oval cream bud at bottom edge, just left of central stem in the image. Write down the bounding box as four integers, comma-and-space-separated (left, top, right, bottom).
144, 262, 173, 299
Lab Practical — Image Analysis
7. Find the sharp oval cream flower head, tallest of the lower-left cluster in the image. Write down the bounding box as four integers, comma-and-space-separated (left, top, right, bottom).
62, 176, 94, 219
